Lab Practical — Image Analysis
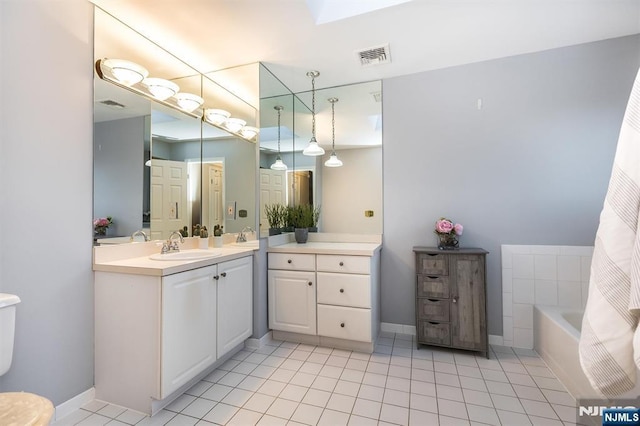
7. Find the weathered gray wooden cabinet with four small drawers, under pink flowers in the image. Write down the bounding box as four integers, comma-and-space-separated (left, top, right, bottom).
413, 247, 489, 357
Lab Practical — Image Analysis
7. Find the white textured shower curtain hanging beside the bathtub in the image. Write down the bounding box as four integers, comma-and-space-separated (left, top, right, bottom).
580, 66, 640, 397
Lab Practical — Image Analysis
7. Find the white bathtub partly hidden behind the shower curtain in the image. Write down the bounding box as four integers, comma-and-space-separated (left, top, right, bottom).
533, 305, 640, 400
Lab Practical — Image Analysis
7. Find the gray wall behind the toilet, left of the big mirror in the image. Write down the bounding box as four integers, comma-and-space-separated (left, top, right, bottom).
0, 0, 93, 404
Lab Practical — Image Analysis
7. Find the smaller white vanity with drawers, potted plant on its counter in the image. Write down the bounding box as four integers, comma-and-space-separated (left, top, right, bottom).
268, 233, 381, 352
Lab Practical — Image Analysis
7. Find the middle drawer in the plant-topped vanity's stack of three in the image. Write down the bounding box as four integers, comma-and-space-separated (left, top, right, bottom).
316, 272, 371, 308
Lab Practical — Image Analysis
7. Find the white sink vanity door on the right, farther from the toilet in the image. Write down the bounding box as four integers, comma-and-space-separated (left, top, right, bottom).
218, 257, 253, 358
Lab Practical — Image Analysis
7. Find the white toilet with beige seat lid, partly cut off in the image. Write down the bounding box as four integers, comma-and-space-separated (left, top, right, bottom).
0, 293, 54, 426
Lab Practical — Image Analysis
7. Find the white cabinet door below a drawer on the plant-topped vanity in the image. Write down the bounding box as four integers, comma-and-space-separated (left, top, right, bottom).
268, 269, 316, 335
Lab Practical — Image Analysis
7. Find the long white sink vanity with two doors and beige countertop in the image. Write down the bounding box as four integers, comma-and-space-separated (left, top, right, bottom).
94, 239, 254, 415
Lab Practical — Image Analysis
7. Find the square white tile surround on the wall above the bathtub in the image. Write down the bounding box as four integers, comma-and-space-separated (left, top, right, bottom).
502, 245, 593, 349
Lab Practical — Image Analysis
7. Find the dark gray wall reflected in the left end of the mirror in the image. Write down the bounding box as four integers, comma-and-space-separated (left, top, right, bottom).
93, 117, 146, 236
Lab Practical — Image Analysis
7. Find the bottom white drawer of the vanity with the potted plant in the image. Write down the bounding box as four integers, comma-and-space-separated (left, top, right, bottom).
318, 305, 371, 342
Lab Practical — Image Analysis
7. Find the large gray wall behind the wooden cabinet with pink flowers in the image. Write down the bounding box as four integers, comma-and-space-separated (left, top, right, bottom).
382, 36, 640, 335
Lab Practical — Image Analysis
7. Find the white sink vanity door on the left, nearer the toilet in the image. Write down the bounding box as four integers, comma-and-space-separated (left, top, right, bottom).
160, 265, 217, 398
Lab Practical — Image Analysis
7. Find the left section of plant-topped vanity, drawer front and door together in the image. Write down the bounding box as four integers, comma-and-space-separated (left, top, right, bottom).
267, 253, 316, 335
